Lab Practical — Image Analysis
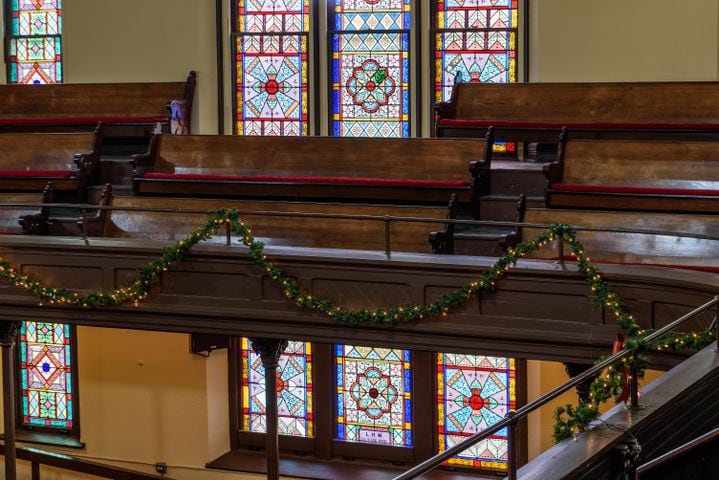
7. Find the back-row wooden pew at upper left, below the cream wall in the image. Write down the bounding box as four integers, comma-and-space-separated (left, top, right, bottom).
0, 72, 196, 136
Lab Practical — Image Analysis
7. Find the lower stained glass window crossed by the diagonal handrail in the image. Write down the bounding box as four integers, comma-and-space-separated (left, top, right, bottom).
437, 353, 517, 470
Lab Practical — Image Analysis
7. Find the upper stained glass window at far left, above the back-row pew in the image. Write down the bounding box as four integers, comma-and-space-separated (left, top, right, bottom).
6, 0, 62, 84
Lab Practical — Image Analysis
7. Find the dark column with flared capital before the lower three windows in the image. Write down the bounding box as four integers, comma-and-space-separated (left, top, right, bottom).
250, 338, 288, 480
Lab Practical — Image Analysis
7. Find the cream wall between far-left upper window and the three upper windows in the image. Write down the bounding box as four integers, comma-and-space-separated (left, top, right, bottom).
63, 0, 217, 133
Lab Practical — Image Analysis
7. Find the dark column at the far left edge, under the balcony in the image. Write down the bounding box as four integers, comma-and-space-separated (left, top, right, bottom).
0, 322, 20, 480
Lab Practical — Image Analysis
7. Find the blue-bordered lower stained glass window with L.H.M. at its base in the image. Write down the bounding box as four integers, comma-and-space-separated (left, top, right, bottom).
336, 345, 412, 447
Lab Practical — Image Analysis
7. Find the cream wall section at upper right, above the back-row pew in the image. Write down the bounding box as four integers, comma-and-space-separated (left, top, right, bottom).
529, 0, 719, 82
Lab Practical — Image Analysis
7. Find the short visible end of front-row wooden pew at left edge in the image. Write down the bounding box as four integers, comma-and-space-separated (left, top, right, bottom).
0, 183, 53, 235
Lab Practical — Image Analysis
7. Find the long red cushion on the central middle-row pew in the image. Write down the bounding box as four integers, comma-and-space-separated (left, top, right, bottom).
144, 172, 469, 187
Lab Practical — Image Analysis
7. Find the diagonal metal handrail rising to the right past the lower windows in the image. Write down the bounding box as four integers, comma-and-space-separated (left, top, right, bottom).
393, 295, 719, 480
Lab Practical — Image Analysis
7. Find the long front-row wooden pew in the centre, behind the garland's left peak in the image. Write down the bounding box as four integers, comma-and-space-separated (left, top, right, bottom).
88, 196, 448, 253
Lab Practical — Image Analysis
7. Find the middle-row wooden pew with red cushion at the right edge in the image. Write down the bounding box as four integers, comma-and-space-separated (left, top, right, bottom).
547, 132, 719, 213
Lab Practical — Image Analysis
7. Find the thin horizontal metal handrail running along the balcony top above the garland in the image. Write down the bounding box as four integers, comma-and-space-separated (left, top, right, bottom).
0, 202, 719, 240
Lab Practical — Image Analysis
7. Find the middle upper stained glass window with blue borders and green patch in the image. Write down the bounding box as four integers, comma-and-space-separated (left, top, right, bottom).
328, 0, 410, 137
